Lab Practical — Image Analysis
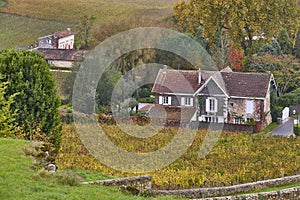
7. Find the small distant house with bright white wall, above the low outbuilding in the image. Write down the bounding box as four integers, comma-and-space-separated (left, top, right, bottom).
38, 28, 75, 49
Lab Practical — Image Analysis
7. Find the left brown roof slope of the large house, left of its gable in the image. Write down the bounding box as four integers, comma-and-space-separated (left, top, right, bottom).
152, 69, 201, 95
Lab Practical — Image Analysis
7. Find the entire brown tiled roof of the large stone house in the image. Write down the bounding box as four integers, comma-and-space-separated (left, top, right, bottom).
152, 69, 271, 98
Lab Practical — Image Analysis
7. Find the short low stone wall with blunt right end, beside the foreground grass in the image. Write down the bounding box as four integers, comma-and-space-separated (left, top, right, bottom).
82, 176, 152, 191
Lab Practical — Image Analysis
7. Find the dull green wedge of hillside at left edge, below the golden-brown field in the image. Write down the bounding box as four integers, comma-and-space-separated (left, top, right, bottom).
0, 13, 73, 48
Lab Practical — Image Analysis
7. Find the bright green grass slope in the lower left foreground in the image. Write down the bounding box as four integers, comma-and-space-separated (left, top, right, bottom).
0, 138, 183, 200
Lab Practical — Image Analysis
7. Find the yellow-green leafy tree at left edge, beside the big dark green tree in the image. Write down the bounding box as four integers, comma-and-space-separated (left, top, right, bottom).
0, 78, 16, 137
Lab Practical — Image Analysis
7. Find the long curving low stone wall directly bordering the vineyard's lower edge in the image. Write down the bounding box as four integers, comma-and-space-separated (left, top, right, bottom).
153, 175, 300, 198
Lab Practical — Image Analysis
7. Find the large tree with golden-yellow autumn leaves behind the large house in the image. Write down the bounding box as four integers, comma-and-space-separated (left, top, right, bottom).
174, 0, 300, 55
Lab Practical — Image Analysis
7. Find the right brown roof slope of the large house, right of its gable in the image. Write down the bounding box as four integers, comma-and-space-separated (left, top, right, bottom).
221, 72, 271, 98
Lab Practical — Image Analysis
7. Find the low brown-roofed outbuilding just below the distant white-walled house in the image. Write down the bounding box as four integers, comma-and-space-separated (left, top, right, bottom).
37, 48, 85, 69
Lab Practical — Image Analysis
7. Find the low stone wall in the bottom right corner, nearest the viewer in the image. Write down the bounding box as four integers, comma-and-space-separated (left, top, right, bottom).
198, 187, 300, 200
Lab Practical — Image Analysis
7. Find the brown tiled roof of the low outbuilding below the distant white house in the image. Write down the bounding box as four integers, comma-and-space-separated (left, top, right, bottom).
37, 49, 85, 61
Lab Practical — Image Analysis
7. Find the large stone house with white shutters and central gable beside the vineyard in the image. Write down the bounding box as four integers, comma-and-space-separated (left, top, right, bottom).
149, 68, 273, 128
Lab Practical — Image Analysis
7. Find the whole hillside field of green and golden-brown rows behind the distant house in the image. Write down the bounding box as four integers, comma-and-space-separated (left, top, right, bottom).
0, 0, 175, 48
